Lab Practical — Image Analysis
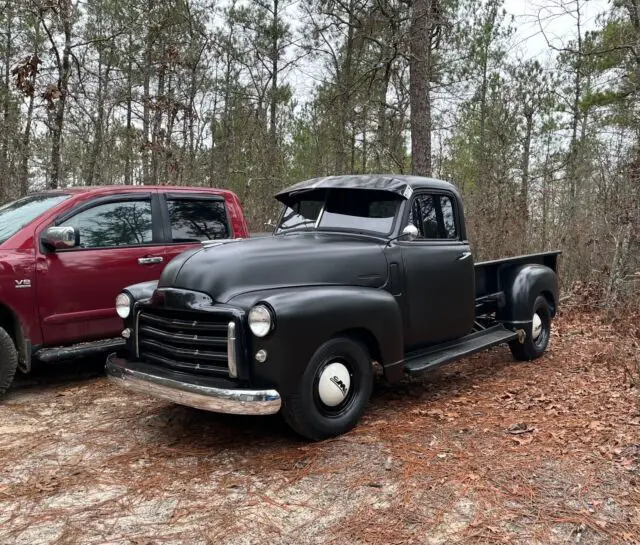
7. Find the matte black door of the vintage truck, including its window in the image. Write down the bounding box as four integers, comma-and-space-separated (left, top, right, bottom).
398, 194, 475, 348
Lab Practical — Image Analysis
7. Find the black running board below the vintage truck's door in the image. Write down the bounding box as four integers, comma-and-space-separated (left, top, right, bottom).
404, 324, 518, 375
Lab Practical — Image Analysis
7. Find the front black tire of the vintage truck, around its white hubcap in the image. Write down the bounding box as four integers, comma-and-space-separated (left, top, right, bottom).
282, 337, 373, 441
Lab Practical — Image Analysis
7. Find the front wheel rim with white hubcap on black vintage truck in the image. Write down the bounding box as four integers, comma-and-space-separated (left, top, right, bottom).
313, 358, 358, 418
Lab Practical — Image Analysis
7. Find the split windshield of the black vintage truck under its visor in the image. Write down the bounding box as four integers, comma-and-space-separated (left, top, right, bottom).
276, 188, 401, 235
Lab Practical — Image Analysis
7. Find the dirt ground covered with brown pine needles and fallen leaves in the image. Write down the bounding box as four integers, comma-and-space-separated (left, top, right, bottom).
0, 312, 640, 545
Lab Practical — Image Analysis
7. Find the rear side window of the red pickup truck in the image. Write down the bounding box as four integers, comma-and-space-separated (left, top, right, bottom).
167, 198, 230, 242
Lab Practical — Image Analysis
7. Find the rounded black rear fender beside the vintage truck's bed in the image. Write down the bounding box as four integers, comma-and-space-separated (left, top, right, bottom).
497, 264, 558, 329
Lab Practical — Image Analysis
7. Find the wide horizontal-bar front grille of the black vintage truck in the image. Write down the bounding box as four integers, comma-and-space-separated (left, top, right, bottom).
136, 308, 232, 376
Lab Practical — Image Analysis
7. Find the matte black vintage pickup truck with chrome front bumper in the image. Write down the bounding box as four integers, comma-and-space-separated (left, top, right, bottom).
106, 175, 559, 440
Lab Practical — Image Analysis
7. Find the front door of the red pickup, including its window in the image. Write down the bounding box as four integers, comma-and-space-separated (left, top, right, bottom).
36, 190, 166, 346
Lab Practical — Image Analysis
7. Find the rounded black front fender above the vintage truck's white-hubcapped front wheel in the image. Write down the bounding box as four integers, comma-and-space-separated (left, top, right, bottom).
230, 286, 404, 394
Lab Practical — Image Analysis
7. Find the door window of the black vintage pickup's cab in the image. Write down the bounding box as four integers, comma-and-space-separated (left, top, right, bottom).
409, 194, 458, 240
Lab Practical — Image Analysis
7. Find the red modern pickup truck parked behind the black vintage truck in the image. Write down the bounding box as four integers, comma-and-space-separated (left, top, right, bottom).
0, 186, 248, 395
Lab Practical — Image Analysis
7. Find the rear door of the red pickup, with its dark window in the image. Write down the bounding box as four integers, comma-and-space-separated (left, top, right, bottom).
160, 192, 238, 261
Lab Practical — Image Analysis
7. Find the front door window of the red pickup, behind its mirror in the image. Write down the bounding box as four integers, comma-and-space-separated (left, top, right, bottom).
61, 200, 153, 248
